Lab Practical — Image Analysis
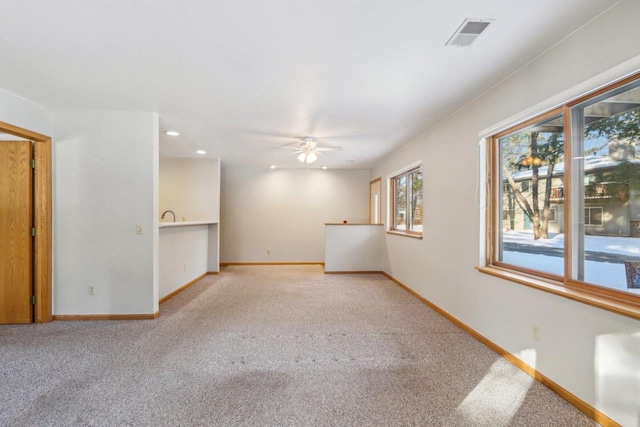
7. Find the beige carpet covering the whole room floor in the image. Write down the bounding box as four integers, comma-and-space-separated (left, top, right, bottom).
0, 266, 596, 426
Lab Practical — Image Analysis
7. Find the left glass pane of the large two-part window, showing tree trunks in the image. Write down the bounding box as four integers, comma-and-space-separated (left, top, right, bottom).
497, 115, 564, 276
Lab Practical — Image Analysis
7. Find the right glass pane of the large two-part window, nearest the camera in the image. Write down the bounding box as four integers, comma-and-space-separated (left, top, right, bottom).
571, 82, 640, 293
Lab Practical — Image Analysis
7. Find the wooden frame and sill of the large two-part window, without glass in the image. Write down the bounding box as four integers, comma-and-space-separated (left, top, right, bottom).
477, 73, 640, 319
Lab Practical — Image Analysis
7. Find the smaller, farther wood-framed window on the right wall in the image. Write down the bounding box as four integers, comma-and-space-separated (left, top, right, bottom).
389, 166, 422, 237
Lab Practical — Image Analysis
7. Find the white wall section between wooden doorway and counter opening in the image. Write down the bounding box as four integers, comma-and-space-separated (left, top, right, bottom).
53, 112, 158, 315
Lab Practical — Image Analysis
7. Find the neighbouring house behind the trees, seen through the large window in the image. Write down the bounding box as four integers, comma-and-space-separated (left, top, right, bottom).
502, 144, 640, 237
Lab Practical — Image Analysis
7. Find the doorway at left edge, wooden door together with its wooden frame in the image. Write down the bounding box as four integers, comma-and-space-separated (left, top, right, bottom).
0, 122, 52, 323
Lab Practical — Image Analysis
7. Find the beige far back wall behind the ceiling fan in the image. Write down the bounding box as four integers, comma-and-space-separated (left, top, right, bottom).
220, 168, 370, 262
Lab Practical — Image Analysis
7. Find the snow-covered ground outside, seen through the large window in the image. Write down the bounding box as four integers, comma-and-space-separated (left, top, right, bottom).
503, 231, 640, 294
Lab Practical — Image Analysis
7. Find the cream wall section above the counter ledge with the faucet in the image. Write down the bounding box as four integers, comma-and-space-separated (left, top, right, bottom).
159, 158, 220, 222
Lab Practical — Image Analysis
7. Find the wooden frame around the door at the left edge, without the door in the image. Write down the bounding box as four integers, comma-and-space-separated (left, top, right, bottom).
0, 118, 53, 323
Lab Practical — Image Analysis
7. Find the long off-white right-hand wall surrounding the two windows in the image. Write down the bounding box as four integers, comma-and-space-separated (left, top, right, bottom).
372, 0, 640, 425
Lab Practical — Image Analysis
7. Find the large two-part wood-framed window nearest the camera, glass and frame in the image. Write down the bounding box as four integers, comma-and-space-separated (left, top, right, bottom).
487, 72, 640, 317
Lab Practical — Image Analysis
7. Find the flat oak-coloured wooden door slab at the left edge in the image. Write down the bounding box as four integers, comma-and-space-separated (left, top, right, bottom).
0, 141, 33, 324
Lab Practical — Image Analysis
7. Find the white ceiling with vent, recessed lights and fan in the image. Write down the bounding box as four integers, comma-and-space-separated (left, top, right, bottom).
0, 0, 617, 168
